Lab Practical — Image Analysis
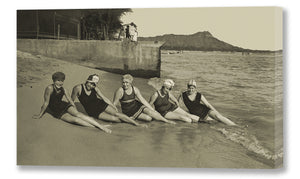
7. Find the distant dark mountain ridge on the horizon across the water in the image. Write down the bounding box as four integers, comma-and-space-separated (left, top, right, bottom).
138, 31, 269, 52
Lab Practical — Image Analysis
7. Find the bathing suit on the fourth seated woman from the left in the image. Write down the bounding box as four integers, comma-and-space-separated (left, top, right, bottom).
153, 91, 178, 116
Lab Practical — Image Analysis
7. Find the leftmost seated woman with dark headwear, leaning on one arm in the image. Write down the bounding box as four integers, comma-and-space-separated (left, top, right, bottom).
33, 72, 111, 133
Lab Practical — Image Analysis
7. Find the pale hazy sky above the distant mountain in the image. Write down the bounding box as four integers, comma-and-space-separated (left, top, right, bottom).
122, 7, 282, 50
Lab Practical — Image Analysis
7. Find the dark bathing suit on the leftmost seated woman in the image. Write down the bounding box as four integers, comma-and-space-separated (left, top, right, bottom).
48, 85, 72, 119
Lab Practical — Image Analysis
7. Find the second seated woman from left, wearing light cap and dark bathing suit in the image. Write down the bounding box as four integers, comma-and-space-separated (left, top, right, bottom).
71, 74, 147, 127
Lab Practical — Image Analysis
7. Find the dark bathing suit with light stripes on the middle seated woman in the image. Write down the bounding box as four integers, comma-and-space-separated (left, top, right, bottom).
120, 86, 146, 119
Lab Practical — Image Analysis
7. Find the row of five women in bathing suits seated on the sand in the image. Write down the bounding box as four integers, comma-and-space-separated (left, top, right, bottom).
33, 72, 236, 133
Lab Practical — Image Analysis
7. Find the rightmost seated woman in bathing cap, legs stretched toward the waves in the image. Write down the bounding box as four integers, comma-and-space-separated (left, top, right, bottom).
178, 80, 236, 126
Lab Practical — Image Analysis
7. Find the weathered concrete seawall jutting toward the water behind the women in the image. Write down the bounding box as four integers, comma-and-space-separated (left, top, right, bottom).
17, 39, 162, 77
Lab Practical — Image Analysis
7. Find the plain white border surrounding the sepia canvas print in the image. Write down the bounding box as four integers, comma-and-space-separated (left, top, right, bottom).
0, 0, 300, 179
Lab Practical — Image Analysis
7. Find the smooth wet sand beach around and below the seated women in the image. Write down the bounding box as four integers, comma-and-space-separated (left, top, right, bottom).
17, 51, 271, 168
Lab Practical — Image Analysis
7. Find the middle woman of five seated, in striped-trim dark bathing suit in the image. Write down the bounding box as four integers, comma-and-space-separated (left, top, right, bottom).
113, 74, 175, 124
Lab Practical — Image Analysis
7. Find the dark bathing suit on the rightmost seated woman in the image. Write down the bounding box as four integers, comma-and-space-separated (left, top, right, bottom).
182, 92, 210, 120
